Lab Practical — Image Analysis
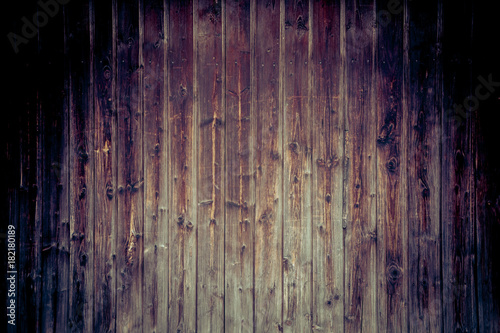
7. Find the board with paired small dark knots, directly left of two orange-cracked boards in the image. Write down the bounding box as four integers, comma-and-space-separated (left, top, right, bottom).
167, 1, 198, 332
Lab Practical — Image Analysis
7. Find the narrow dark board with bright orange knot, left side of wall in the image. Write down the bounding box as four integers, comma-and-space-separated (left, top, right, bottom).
92, 0, 118, 332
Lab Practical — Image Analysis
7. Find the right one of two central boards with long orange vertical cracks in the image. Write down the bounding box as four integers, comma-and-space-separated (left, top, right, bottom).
224, 1, 255, 332
